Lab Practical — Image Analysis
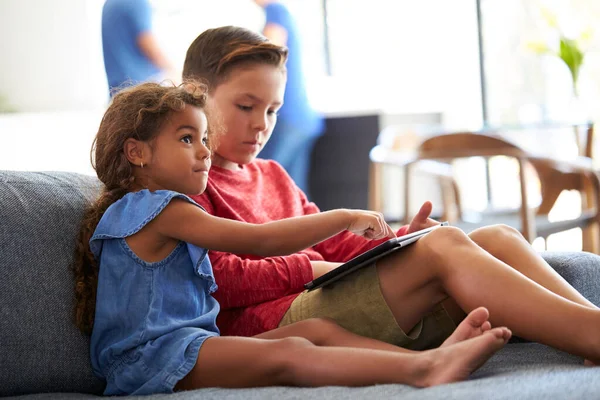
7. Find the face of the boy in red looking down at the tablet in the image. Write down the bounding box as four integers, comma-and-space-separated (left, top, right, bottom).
208, 64, 285, 170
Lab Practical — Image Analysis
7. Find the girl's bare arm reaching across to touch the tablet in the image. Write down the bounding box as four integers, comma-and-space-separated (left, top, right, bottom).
155, 199, 395, 256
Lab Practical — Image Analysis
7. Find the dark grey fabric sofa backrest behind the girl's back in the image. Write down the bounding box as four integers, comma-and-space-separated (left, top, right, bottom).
0, 171, 104, 396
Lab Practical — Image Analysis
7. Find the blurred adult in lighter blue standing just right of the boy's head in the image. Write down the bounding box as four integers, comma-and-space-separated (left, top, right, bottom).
254, 0, 324, 195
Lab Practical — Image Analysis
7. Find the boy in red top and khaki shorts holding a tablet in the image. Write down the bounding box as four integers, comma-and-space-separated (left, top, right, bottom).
183, 27, 600, 362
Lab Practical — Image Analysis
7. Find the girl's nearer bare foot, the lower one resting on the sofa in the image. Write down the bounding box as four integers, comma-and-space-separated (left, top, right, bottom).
416, 327, 512, 387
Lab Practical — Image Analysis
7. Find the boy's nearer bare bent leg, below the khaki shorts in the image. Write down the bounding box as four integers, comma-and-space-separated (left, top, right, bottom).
377, 227, 600, 362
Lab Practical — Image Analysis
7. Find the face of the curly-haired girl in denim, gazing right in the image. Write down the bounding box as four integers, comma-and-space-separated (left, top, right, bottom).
140, 105, 211, 194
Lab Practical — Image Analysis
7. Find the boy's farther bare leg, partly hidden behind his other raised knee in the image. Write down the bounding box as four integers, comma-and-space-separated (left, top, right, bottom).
469, 225, 597, 308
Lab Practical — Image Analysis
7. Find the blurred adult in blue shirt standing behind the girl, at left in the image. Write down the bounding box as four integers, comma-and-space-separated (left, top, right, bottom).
102, 0, 178, 96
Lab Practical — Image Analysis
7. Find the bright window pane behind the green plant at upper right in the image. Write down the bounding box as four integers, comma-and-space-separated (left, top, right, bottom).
481, 0, 600, 125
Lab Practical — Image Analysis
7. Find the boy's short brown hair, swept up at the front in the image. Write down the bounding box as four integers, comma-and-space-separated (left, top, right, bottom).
183, 26, 288, 91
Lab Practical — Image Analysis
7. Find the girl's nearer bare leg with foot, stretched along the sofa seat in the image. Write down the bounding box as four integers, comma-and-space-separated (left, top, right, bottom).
176, 324, 510, 390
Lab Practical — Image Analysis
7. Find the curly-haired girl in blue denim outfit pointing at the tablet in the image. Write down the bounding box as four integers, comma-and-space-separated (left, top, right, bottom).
75, 82, 510, 395
